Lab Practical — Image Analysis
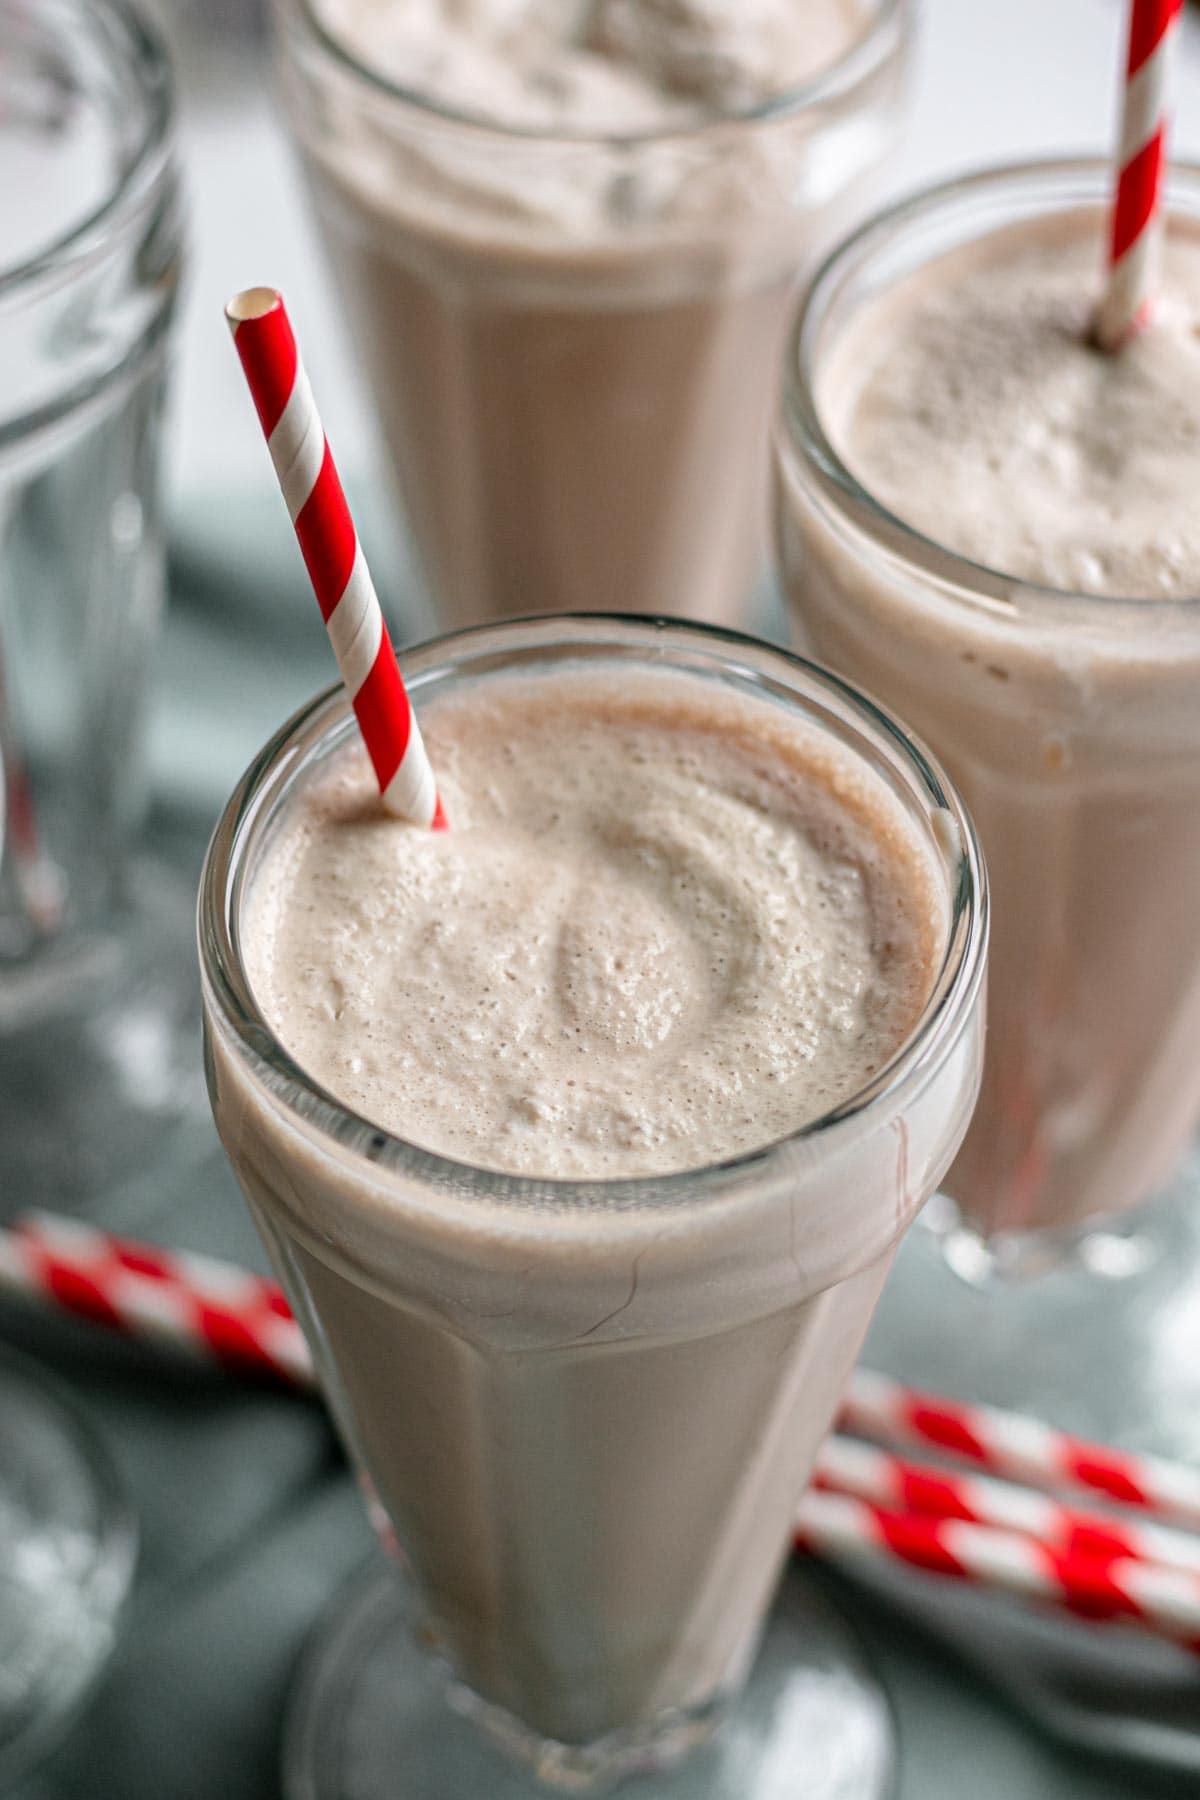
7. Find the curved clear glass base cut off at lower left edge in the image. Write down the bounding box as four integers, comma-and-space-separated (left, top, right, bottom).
0, 1350, 137, 1789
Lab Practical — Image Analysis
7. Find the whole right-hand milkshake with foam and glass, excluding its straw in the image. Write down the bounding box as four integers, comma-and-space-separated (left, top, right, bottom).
779, 164, 1200, 1235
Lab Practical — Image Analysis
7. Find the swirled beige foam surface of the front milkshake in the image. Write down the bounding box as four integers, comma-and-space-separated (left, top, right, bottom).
245, 673, 946, 1179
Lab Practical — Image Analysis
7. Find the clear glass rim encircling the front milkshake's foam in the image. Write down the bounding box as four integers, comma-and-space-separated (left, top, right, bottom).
198, 614, 988, 1210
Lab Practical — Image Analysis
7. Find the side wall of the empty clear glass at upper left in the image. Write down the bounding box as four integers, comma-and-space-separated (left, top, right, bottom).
0, 0, 184, 964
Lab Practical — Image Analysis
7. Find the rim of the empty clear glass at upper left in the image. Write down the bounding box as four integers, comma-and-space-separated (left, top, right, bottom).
0, 0, 173, 301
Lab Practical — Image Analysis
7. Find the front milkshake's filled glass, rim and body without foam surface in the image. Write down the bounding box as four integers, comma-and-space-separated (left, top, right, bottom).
200, 619, 986, 1800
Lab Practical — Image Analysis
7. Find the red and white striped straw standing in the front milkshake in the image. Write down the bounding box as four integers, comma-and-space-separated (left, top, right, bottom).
225, 288, 446, 830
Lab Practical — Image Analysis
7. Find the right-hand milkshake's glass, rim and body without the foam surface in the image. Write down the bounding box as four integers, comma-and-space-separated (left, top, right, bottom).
777, 160, 1200, 1271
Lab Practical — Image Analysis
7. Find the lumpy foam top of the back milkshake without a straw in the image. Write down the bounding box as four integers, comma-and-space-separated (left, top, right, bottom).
315, 0, 873, 133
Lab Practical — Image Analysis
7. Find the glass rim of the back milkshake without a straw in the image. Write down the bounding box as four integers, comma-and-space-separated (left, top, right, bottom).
273, 0, 912, 148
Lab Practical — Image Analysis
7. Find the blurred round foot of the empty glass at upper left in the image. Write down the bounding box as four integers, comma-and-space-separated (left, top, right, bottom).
0, 864, 205, 1219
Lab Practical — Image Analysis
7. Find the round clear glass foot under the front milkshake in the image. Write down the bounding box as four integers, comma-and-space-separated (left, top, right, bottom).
284, 1564, 894, 1800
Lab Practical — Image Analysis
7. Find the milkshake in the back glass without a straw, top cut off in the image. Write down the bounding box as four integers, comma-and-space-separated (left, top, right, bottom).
277, 0, 909, 625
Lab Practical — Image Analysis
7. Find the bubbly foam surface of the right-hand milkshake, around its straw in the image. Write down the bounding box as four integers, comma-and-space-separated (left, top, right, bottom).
820, 214, 1200, 599
